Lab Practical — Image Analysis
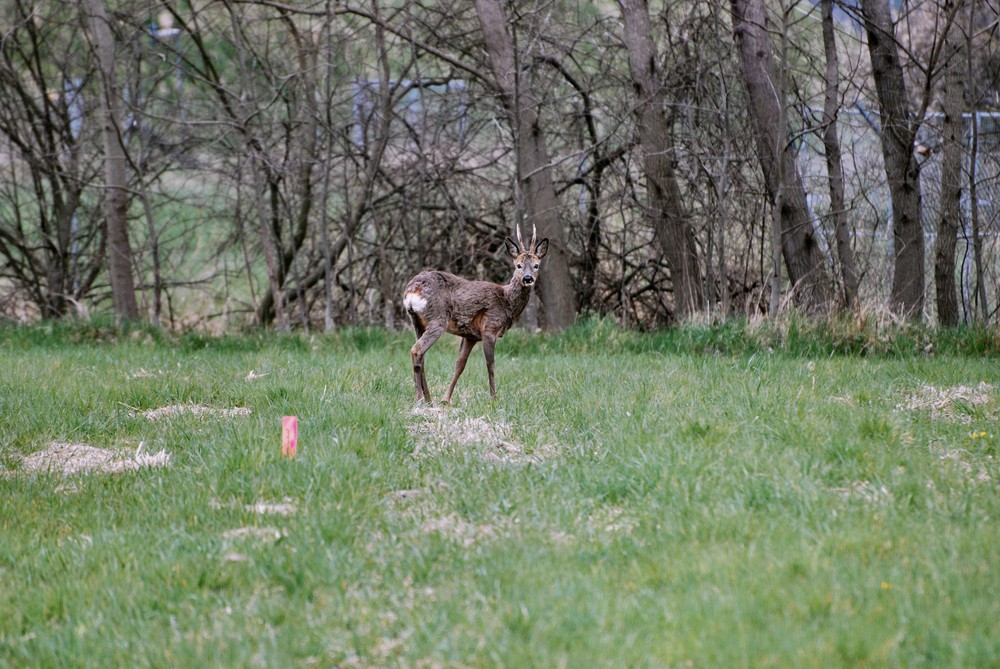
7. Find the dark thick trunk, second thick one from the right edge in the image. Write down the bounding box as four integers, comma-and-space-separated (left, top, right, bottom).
861, 0, 924, 320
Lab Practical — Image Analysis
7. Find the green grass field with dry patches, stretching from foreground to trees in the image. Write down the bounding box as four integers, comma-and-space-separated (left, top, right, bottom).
0, 323, 1000, 668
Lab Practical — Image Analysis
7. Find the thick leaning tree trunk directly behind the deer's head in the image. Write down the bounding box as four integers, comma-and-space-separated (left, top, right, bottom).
476, 0, 576, 330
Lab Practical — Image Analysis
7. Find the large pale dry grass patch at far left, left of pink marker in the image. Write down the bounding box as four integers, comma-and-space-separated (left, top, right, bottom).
8, 441, 170, 475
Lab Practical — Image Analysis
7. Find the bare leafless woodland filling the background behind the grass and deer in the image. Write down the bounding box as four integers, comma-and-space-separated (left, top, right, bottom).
0, 0, 1000, 331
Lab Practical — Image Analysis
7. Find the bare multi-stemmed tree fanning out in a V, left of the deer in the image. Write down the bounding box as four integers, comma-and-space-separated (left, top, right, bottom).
171, 0, 372, 330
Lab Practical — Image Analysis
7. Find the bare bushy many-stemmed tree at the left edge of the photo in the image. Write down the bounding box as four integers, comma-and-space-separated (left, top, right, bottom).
0, 0, 98, 318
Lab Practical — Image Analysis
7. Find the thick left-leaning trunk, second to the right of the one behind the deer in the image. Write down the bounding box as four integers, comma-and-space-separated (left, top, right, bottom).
732, 0, 830, 314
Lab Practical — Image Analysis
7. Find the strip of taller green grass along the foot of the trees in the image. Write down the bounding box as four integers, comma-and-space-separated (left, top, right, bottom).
0, 313, 1000, 358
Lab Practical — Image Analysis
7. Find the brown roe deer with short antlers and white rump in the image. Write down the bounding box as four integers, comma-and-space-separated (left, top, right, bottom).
403, 225, 549, 404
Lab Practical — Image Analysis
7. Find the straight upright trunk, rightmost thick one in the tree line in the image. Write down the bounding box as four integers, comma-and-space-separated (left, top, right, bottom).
934, 0, 965, 327
